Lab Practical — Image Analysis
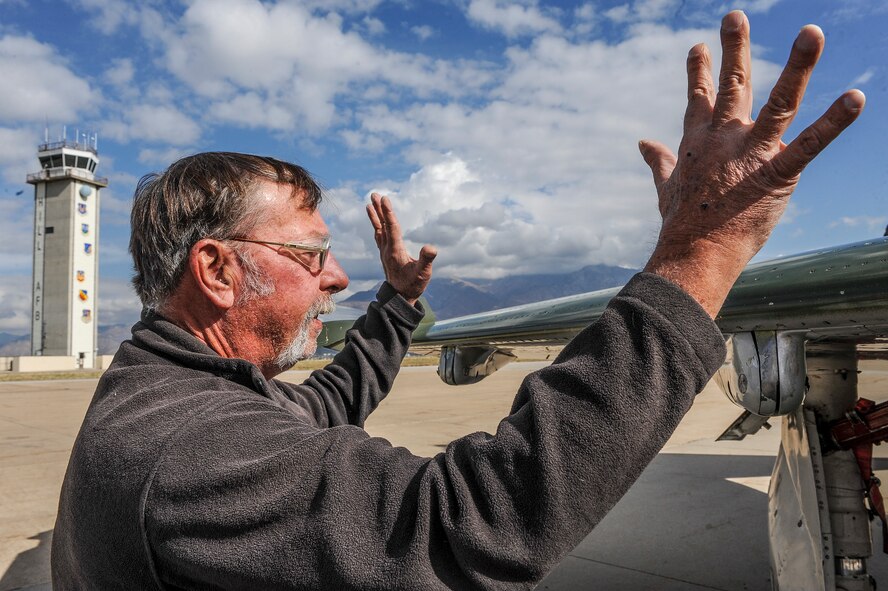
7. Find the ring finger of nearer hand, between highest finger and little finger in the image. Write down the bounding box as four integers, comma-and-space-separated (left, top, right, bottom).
752, 25, 823, 145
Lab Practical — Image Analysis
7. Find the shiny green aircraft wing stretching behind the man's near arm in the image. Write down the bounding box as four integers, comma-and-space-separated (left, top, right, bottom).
414, 238, 888, 346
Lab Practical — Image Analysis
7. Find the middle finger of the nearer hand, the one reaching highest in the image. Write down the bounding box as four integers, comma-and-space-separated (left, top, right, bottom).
712, 10, 752, 126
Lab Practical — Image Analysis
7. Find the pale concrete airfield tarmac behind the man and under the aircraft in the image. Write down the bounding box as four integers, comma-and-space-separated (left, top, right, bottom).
0, 363, 888, 591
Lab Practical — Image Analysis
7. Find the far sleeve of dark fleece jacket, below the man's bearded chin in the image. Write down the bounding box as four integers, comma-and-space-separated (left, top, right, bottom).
274, 282, 424, 427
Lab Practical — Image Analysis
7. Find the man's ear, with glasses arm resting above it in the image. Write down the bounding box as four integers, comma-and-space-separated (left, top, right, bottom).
188, 238, 239, 310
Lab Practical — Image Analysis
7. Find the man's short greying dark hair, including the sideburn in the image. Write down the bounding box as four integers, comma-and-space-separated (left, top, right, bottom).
129, 152, 322, 309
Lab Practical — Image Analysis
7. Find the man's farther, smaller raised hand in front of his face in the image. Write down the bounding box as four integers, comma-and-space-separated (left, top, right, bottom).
367, 193, 438, 304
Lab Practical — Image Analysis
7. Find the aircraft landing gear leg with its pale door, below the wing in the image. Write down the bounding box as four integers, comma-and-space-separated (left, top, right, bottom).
768, 344, 875, 591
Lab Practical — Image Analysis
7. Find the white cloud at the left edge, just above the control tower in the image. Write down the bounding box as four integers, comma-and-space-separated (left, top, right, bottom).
0, 35, 98, 123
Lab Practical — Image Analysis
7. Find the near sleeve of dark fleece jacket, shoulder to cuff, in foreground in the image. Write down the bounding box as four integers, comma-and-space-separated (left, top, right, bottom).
144, 274, 725, 590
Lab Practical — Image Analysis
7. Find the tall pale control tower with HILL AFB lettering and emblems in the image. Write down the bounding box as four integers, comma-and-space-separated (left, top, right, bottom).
27, 132, 108, 368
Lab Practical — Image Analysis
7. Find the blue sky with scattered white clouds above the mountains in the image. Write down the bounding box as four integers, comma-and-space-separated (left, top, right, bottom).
0, 0, 888, 334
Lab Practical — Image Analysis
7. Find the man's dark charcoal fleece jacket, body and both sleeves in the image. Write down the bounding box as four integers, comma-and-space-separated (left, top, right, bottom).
52, 274, 725, 591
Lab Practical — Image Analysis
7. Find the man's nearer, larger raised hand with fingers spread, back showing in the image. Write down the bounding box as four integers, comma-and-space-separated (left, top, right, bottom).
639, 11, 864, 317
